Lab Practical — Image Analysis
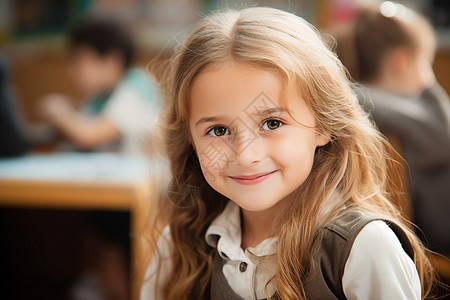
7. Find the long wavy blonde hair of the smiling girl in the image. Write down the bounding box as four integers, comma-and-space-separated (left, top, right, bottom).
142, 7, 433, 300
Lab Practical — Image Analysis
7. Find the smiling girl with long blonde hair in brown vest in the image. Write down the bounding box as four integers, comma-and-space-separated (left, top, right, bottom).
141, 8, 432, 300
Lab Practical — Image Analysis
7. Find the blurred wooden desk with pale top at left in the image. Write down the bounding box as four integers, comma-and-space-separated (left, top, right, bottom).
0, 153, 156, 299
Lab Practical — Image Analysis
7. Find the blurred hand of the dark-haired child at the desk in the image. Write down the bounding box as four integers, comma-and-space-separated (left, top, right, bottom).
39, 94, 75, 122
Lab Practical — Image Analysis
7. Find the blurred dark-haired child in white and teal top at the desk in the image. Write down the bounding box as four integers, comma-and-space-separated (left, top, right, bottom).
41, 19, 159, 154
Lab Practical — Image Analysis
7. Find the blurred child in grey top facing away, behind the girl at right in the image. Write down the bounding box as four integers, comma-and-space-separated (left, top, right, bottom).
335, 2, 450, 256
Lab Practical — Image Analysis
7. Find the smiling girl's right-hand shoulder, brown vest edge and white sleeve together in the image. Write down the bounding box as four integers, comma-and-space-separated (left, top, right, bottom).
306, 208, 420, 299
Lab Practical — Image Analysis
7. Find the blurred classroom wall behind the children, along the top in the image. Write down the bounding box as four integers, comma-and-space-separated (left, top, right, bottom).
0, 0, 450, 122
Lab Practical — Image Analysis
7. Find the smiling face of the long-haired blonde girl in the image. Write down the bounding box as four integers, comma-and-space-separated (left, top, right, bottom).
189, 62, 329, 212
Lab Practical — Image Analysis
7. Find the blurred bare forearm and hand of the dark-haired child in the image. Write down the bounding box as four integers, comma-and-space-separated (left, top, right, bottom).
41, 95, 120, 149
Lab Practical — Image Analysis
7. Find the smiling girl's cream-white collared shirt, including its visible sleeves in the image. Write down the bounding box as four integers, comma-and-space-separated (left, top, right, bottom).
141, 201, 421, 300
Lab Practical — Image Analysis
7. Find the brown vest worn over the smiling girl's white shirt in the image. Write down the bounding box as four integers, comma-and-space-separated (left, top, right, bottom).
210, 210, 414, 300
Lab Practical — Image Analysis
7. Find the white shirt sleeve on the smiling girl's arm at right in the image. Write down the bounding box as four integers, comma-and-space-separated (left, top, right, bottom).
342, 221, 421, 300
